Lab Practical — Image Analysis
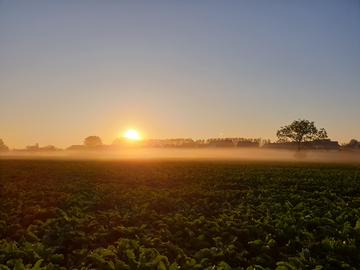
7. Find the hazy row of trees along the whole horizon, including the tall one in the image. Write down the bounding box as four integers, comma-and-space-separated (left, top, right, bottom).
0, 119, 360, 152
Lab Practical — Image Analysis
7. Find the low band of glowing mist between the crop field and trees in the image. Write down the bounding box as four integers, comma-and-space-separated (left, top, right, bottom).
0, 148, 360, 163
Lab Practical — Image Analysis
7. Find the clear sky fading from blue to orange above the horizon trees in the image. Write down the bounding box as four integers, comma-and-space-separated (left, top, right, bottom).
0, 0, 360, 148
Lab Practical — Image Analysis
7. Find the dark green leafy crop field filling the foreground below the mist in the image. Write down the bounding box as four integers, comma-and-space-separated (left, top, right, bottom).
0, 160, 360, 270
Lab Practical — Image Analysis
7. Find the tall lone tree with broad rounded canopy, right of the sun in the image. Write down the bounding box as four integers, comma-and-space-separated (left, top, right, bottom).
276, 119, 328, 151
